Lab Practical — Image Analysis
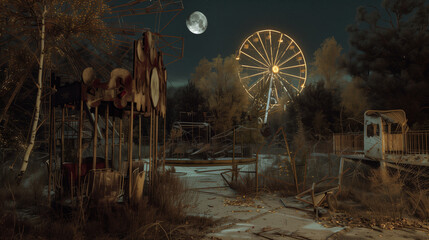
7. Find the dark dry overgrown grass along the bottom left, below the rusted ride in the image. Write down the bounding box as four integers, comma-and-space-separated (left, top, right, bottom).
0, 165, 216, 239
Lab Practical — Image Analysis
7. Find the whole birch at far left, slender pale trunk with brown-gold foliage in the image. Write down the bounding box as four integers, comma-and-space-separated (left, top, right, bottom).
0, 0, 112, 180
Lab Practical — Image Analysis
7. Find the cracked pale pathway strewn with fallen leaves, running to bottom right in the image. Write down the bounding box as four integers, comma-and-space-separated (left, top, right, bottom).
171, 167, 429, 240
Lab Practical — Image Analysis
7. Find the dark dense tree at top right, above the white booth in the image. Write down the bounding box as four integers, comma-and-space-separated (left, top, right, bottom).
344, 0, 429, 127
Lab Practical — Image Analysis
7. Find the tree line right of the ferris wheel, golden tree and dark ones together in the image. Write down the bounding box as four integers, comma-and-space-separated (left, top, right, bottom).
280, 0, 429, 142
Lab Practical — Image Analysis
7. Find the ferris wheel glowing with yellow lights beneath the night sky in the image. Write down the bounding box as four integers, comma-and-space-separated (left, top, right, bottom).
236, 30, 307, 123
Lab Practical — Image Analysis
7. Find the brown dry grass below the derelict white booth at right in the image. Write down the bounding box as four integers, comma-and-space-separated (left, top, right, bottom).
338, 164, 429, 227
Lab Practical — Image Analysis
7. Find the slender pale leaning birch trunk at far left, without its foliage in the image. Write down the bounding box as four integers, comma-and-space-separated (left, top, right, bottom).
18, 6, 47, 182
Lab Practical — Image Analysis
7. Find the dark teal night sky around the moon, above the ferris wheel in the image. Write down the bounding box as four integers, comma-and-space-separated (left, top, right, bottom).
163, 0, 374, 87
